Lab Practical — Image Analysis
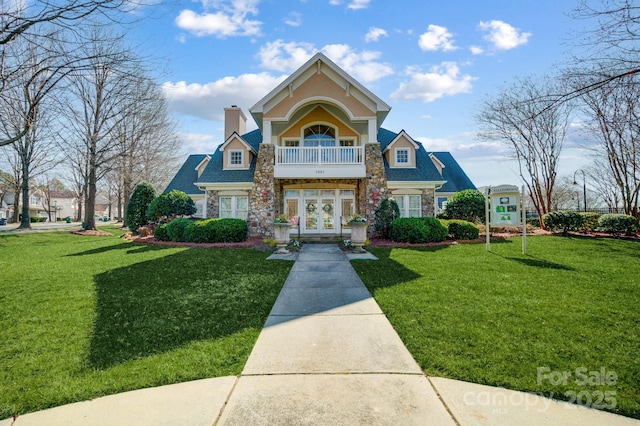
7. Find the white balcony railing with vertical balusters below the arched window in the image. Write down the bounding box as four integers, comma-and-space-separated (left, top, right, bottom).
276, 146, 364, 165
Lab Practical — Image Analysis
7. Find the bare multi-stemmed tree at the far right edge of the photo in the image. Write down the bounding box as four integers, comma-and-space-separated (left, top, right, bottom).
580, 71, 640, 216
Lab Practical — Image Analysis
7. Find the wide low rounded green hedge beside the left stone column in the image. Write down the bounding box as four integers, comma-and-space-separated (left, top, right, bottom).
184, 218, 249, 243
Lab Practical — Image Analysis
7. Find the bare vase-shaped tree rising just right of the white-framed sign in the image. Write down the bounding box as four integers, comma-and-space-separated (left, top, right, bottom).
476, 77, 571, 225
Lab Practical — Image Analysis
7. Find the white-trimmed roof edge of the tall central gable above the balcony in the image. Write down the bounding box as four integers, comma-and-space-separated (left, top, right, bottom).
249, 52, 391, 129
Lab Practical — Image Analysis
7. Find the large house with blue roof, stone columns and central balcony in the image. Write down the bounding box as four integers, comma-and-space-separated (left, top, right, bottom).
166, 53, 475, 236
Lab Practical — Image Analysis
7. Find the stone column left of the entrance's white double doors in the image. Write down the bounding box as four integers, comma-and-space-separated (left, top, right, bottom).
247, 143, 275, 238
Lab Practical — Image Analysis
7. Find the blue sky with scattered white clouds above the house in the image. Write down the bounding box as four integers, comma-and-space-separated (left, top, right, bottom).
130, 0, 589, 186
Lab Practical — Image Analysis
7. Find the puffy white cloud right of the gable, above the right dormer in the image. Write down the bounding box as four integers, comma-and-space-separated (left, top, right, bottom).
391, 62, 477, 102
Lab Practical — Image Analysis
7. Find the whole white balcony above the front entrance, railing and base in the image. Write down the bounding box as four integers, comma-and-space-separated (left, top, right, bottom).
274, 146, 366, 179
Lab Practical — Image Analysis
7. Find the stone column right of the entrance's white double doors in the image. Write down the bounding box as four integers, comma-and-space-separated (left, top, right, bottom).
364, 143, 389, 237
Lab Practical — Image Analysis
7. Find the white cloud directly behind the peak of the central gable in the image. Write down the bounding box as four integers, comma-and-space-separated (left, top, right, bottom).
258, 40, 393, 83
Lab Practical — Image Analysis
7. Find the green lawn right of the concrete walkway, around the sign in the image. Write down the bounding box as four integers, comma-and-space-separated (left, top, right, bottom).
353, 237, 640, 418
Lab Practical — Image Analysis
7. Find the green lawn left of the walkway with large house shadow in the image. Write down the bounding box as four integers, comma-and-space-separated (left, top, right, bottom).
0, 228, 292, 419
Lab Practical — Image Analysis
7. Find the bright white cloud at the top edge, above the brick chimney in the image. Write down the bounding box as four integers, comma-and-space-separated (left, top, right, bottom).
175, 0, 262, 38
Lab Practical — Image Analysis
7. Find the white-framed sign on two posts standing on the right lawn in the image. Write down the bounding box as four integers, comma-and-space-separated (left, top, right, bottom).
485, 185, 527, 254
